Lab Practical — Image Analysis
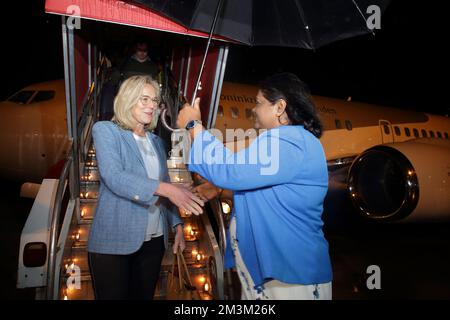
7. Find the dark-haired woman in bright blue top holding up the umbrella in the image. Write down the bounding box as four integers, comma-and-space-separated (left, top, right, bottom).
178, 73, 332, 299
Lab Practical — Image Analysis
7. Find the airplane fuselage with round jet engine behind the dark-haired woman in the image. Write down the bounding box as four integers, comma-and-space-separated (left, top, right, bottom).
211, 82, 450, 222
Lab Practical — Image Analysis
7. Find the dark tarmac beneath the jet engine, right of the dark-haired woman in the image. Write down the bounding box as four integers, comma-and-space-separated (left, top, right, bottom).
323, 184, 450, 300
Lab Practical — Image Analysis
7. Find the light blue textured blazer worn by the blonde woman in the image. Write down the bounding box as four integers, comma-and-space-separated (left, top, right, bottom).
88, 121, 182, 254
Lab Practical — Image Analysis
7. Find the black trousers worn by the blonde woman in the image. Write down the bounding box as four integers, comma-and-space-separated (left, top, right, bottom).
89, 236, 164, 300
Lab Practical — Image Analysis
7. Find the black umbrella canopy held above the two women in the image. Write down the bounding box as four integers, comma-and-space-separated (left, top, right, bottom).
133, 0, 389, 49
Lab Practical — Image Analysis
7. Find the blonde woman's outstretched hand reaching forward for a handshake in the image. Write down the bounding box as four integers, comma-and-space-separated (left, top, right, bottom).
155, 182, 205, 215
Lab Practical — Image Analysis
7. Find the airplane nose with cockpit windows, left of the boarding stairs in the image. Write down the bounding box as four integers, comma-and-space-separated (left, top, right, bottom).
0, 80, 70, 183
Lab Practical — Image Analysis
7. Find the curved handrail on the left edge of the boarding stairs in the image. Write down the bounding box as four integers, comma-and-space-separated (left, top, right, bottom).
47, 157, 73, 300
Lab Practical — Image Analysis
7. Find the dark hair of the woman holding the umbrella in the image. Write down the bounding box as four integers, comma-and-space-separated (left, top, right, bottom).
259, 72, 323, 138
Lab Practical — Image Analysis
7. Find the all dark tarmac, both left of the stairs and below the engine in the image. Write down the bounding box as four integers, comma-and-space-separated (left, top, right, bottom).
0, 182, 450, 300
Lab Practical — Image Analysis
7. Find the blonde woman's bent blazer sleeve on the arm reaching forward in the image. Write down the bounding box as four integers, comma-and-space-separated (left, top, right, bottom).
92, 122, 159, 206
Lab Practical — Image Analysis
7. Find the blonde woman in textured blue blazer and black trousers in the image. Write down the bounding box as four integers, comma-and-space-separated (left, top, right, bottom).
88, 76, 203, 299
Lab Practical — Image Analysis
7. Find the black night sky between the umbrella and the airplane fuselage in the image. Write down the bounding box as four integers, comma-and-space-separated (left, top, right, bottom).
227, 0, 450, 114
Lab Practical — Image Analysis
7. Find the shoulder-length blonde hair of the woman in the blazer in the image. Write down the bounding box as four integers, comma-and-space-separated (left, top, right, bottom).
111, 75, 160, 130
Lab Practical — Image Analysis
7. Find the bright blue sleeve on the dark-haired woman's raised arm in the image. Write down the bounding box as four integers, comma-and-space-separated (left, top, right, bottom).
189, 129, 304, 191
